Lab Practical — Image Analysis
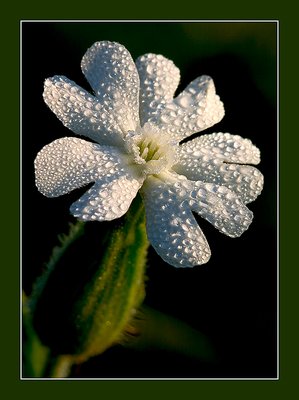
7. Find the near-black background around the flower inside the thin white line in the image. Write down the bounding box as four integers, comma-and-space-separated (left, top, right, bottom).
22, 22, 277, 378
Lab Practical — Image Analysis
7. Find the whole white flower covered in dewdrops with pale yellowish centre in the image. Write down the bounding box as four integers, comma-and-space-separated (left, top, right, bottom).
35, 41, 263, 267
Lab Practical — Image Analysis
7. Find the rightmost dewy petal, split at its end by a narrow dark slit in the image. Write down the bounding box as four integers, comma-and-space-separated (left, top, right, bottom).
173, 133, 264, 204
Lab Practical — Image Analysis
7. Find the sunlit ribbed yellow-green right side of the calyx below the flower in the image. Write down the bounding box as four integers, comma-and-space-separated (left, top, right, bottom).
75, 196, 149, 361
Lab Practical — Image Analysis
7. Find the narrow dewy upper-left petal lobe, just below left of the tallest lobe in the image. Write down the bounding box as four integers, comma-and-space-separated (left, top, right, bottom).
43, 76, 123, 145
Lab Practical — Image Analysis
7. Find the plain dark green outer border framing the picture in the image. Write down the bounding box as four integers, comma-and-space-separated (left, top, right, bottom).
1, 1, 298, 399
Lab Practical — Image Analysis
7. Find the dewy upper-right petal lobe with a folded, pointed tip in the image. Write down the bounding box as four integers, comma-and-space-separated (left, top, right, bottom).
149, 75, 224, 141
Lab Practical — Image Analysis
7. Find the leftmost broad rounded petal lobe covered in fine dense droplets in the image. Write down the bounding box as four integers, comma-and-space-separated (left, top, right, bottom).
34, 137, 129, 197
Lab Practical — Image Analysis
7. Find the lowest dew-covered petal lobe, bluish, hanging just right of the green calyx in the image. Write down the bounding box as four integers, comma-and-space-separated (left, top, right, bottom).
142, 177, 211, 267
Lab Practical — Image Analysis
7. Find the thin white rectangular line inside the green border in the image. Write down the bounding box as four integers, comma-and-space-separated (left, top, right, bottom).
19, 19, 280, 381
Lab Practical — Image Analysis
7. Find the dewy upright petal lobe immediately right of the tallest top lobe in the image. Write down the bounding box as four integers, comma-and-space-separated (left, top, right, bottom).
136, 53, 180, 125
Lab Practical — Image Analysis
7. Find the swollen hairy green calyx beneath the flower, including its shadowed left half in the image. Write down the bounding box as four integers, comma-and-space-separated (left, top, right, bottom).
30, 195, 149, 376
